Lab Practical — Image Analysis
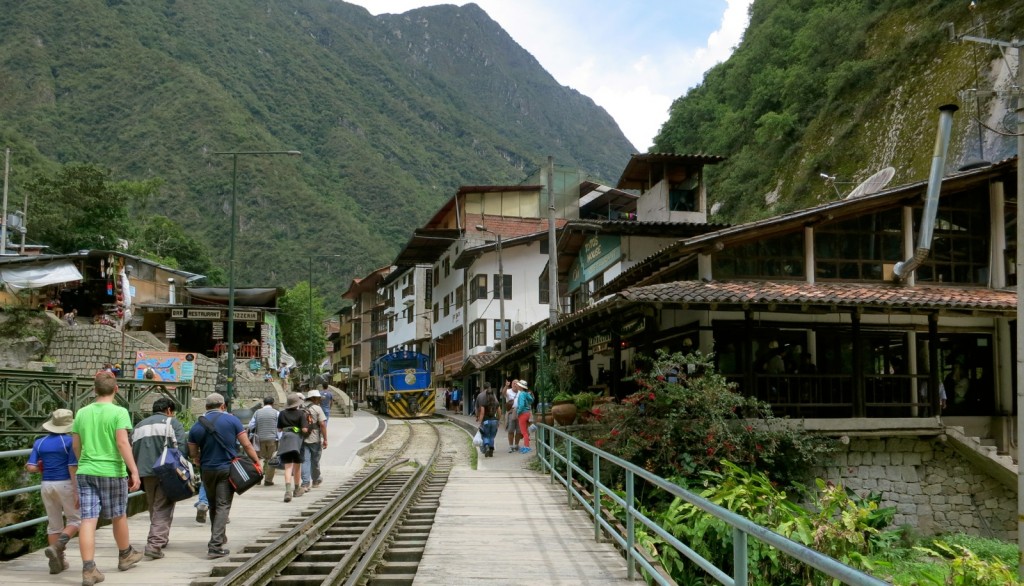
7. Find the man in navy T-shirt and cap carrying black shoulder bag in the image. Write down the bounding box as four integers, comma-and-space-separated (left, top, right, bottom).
188, 392, 262, 559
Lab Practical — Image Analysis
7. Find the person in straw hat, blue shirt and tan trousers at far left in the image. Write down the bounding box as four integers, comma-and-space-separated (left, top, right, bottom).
25, 409, 82, 574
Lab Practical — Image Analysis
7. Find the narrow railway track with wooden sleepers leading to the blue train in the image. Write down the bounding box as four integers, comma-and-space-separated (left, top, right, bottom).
193, 420, 452, 586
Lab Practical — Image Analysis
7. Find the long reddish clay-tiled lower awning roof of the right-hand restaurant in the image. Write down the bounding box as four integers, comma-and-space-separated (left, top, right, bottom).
618, 281, 1017, 312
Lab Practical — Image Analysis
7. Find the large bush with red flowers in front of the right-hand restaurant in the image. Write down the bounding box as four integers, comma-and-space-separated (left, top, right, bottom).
592, 351, 834, 485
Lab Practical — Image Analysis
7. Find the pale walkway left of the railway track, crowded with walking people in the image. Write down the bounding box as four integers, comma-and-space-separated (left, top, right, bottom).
0, 411, 380, 586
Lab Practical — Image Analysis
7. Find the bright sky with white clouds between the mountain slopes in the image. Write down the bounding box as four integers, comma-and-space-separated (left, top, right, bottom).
347, 0, 753, 152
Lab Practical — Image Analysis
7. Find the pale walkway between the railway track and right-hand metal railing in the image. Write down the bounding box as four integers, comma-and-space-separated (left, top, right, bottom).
414, 409, 628, 586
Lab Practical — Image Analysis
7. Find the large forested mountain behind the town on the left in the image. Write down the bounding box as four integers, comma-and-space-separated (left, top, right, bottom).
0, 0, 635, 291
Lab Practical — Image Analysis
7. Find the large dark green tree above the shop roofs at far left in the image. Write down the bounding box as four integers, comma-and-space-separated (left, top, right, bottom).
26, 164, 151, 252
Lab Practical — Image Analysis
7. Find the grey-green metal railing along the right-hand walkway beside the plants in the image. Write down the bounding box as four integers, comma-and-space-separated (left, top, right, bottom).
538, 424, 886, 586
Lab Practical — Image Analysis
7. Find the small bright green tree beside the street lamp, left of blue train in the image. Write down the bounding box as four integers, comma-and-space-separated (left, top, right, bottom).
278, 281, 327, 373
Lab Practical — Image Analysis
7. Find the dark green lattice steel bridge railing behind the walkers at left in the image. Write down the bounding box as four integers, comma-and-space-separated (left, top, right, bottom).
0, 369, 193, 441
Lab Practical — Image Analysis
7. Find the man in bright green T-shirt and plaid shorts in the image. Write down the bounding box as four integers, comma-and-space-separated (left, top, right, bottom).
72, 371, 142, 586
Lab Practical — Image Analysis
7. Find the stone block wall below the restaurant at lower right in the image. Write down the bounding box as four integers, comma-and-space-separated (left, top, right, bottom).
814, 435, 1017, 541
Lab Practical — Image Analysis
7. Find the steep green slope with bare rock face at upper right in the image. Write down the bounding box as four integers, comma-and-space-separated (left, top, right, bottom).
652, 0, 1024, 222
